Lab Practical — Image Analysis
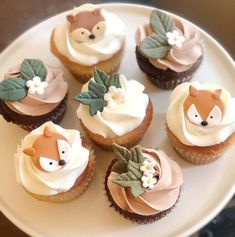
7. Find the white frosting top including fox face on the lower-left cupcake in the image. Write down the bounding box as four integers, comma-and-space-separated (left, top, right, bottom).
15, 122, 89, 195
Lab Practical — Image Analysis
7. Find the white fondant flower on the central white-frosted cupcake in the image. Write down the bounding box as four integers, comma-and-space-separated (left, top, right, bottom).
104, 86, 125, 108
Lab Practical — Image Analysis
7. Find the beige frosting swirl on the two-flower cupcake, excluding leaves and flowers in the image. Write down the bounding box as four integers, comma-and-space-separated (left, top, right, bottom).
107, 148, 183, 216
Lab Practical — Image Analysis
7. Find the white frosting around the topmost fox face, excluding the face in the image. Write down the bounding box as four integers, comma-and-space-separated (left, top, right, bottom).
54, 4, 125, 66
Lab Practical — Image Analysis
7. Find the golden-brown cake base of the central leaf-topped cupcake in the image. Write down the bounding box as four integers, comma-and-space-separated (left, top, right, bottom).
80, 100, 153, 151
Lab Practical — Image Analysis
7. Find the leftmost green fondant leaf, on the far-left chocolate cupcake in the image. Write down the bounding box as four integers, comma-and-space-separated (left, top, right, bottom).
0, 77, 27, 101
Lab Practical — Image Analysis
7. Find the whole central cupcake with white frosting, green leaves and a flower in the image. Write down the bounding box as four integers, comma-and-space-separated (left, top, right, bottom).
75, 68, 153, 150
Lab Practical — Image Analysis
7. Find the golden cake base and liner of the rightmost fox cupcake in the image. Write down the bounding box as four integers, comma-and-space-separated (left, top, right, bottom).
167, 127, 235, 165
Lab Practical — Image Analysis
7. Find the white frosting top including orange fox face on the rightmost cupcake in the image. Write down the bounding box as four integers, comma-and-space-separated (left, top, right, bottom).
166, 83, 235, 146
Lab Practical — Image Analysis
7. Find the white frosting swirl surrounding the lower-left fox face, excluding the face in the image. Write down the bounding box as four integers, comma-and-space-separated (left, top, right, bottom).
15, 122, 89, 195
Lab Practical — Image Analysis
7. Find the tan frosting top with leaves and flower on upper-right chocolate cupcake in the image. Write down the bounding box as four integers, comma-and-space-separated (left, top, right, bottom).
136, 10, 203, 72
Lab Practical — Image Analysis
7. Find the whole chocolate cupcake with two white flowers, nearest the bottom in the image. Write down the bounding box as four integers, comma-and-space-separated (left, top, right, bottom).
105, 144, 183, 224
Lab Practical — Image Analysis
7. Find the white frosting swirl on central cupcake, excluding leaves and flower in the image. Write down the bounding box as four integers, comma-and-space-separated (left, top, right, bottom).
77, 75, 149, 138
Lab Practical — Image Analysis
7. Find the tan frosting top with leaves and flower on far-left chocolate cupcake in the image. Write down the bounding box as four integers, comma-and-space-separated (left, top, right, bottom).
0, 59, 68, 116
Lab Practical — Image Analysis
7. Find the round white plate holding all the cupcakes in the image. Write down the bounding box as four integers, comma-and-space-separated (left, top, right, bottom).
0, 4, 235, 237
